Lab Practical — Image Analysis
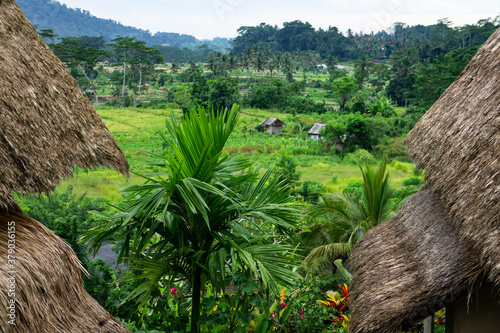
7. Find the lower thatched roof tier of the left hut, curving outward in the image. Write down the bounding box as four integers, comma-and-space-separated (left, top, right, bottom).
0, 212, 130, 333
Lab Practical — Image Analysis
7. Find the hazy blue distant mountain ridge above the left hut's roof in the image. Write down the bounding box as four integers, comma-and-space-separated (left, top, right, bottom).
16, 0, 229, 48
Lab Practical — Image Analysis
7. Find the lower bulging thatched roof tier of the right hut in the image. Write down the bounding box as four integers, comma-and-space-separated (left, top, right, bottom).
349, 187, 482, 332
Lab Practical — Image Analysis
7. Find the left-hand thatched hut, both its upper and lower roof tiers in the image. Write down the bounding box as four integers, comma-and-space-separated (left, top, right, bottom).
0, 0, 129, 333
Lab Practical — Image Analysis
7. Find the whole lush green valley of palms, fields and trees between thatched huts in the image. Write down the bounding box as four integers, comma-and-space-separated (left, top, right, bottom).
15, 1, 500, 333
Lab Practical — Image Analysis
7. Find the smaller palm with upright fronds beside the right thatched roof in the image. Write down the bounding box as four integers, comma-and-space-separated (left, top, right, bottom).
303, 160, 414, 266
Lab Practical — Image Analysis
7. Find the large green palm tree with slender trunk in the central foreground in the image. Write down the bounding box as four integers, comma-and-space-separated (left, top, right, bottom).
87, 105, 299, 332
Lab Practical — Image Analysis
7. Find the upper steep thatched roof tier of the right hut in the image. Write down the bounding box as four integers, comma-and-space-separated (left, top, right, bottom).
406, 30, 500, 283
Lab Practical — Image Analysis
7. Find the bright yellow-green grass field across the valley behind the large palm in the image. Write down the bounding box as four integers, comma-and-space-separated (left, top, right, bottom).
42, 108, 414, 202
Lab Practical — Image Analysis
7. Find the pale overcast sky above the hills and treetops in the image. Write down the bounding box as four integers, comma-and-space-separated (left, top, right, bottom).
57, 0, 500, 39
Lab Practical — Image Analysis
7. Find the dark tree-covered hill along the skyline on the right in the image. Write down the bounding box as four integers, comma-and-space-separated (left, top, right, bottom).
233, 18, 498, 60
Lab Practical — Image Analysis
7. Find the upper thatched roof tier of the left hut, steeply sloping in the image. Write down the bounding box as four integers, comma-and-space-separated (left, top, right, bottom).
0, 0, 128, 209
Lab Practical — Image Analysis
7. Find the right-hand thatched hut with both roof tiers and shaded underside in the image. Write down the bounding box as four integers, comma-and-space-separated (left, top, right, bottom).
349, 30, 500, 333
